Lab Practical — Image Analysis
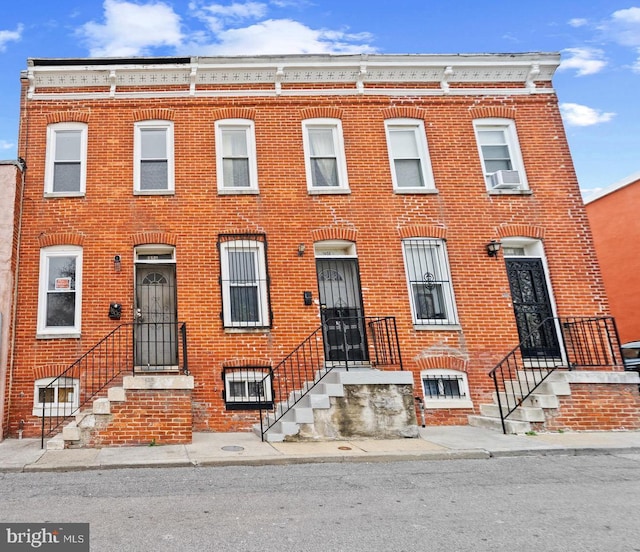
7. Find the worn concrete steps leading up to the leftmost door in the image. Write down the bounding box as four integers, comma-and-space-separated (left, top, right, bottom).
46, 387, 126, 450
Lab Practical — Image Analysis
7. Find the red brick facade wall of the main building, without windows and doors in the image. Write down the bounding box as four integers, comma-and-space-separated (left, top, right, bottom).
5, 74, 608, 432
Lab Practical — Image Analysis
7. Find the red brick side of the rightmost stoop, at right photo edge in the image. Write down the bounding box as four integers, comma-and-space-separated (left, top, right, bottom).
544, 383, 640, 431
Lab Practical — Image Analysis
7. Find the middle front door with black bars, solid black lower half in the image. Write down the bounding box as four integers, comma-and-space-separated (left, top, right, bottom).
316, 258, 368, 362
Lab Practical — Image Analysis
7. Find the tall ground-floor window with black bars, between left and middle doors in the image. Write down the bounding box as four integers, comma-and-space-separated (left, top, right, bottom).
218, 234, 271, 328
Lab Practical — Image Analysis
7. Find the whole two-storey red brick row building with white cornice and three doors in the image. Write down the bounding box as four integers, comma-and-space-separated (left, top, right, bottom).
5, 54, 632, 442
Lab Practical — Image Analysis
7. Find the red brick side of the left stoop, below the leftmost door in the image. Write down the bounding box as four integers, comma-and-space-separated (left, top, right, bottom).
88, 389, 193, 448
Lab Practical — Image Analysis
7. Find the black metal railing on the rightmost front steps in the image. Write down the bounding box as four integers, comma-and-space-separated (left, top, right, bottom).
489, 316, 622, 434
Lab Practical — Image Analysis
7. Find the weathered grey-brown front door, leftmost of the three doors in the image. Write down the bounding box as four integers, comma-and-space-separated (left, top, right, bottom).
134, 265, 178, 370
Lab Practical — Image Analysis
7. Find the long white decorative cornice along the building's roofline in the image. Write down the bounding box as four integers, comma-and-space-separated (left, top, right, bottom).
25, 54, 560, 98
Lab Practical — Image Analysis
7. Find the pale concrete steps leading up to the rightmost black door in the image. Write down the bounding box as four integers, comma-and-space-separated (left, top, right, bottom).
468, 370, 571, 434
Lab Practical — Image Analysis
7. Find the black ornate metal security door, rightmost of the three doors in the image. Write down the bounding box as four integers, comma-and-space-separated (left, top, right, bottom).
506, 258, 560, 358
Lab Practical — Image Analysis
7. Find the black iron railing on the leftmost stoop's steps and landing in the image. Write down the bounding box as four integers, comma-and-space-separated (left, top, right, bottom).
38, 322, 189, 447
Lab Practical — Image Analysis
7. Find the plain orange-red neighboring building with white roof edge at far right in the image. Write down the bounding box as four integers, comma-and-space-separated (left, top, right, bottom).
585, 173, 640, 343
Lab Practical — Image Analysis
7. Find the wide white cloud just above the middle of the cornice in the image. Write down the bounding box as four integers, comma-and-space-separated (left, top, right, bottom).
185, 19, 375, 55
